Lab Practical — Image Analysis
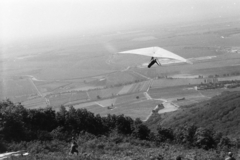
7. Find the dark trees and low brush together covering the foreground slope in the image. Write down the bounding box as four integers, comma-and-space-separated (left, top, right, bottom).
0, 97, 239, 160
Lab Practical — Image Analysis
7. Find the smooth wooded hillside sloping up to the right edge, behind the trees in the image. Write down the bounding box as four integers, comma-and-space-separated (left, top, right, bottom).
146, 92, 240, 137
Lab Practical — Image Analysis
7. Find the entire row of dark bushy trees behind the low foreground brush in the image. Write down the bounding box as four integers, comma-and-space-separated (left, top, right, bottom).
0, 100, 236, 152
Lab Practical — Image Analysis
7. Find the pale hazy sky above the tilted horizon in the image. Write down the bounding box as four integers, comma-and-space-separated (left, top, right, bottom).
0, 0, 240, 42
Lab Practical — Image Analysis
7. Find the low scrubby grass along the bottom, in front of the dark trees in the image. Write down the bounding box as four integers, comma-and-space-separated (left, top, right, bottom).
4, 137, 238, 160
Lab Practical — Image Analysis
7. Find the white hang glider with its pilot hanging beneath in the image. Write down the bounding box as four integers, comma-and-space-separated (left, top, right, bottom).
119, 47, 192, 68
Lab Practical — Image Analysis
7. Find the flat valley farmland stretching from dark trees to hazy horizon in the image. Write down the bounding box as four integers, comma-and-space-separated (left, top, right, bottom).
0, 20, 240, 119
